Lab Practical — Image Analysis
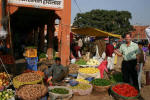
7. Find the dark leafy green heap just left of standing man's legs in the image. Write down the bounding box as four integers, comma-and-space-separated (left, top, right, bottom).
110, 73, 123, 84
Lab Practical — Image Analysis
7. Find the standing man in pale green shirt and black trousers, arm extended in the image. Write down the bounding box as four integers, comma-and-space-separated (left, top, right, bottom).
114, 34, 140, 90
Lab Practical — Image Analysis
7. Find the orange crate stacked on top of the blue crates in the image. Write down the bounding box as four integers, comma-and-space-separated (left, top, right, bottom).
24, 47, 37, 57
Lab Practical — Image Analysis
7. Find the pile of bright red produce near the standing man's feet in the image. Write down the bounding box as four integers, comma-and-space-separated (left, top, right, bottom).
112, 84, 138, 97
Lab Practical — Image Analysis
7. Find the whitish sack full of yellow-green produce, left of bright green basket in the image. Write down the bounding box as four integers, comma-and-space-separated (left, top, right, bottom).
70, 83, 93, 96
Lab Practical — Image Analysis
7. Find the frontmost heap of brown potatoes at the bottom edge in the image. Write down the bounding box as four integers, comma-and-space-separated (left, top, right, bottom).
16, 84, 48, 100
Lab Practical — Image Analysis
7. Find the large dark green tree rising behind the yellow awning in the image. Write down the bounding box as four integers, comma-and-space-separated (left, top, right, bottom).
73, 9, 133, 35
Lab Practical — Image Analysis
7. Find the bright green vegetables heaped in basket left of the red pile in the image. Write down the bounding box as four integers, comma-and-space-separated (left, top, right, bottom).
91, 79, 111, 86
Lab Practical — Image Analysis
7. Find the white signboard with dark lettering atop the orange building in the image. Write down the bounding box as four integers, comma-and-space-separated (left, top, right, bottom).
8, 0, 64, 9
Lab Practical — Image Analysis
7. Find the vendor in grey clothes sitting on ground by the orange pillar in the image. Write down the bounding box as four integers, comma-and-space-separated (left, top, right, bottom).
45, 57, 68, 82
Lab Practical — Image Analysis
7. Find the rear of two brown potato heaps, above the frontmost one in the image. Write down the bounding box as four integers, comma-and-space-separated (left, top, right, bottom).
16, 72, 41, 82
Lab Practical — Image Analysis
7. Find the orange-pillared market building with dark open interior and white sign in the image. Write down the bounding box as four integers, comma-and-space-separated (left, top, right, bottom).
0, 0, 71, 65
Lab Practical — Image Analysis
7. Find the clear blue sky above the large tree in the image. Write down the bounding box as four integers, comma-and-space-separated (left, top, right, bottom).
71, 0, 150, 25
